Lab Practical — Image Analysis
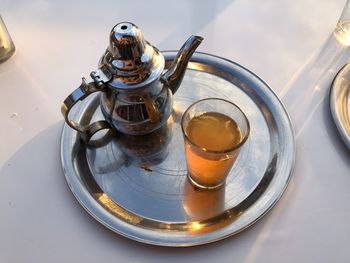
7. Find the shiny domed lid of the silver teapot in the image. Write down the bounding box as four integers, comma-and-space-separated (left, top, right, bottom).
99, 22, 164, 89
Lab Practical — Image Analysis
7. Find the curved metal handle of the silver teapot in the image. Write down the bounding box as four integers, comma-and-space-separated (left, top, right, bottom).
61, 78, 111, 142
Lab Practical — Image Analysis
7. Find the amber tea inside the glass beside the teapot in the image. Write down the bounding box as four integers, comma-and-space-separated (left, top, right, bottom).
185, 112, 242, 189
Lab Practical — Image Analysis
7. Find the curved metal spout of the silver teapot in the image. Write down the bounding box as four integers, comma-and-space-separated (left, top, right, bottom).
162, 35, 203, 93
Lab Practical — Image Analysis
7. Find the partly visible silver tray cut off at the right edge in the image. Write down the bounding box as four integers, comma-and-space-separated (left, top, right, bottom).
330, 63, 350, 149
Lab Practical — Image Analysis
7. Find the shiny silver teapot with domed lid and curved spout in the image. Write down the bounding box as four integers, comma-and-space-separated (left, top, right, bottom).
61, 22, 203, 141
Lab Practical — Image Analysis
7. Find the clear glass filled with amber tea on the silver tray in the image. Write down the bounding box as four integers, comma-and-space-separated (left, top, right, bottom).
181, 98, 250, 189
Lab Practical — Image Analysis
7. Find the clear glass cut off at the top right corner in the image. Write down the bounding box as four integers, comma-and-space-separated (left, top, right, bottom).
334, 0, 350, 46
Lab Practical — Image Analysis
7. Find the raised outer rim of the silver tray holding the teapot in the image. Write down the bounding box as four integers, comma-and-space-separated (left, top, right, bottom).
61, 51, 296, 247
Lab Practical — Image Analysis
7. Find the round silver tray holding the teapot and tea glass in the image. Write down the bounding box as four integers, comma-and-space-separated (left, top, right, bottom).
61, 52, 295, 246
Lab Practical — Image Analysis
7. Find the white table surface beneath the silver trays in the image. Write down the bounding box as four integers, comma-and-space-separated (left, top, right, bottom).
0, 0, 350, 263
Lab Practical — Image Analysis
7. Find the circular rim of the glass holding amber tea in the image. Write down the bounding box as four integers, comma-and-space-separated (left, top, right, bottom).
181, 98, 250, 153
